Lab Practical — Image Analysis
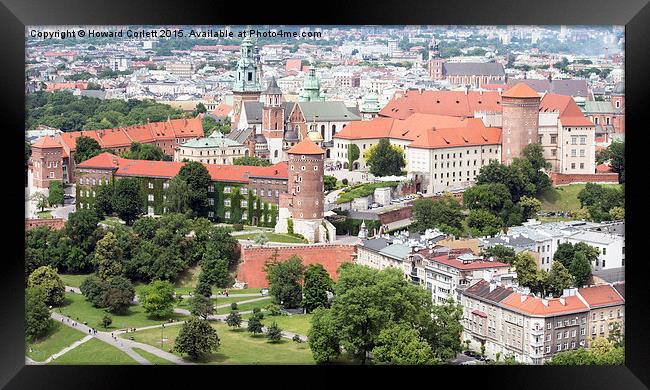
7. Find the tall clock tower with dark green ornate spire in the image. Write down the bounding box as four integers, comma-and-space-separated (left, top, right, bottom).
231, 37, 262, 128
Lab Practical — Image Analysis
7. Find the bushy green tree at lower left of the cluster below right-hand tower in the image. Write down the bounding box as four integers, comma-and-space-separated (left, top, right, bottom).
411, 194, 463, 236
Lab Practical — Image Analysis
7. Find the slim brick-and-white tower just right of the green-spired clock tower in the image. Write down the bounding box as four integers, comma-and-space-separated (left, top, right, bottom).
262, 77, 285, 164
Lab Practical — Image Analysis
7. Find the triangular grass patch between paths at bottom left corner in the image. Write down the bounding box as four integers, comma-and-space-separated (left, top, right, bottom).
49, 339, 138, 365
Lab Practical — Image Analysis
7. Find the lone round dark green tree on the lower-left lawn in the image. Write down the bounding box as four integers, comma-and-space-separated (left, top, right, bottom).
174, 317, 220, 360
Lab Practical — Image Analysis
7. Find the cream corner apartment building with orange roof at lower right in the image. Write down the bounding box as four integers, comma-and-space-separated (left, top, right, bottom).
461, 280, 624, 364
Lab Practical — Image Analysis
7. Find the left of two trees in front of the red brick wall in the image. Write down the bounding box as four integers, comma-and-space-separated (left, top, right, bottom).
265, 255, 305, 308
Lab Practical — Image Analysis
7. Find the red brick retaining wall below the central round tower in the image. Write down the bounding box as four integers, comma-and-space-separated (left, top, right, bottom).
236, 245, 356, 288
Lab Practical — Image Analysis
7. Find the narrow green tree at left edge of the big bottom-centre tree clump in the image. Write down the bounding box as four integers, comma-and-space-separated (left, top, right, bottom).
307, 307, 341, 364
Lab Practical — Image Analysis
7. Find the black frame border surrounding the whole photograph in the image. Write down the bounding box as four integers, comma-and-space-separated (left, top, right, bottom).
0, 0, 650, 390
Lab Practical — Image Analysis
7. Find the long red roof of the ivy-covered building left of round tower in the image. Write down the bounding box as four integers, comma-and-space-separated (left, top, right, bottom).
78, 152, 289, 183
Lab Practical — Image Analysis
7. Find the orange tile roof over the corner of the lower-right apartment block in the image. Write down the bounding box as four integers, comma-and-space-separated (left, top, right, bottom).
501, 293, 589, 317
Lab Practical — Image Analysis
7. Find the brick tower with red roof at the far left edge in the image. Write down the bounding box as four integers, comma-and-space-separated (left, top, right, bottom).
31, 135, 63, 188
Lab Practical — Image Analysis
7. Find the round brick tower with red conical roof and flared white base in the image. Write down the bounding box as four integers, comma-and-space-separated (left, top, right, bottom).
275, 138, 336, 243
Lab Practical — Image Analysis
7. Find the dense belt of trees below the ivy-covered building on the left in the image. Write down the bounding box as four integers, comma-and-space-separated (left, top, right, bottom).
25, 210, 239, 287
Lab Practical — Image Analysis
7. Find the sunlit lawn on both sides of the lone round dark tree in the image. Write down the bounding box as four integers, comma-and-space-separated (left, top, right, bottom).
130, 323, 314, 364
